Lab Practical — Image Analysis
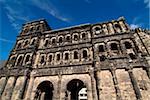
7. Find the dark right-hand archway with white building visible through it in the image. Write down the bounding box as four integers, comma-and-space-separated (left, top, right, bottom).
66, 79, 87, 100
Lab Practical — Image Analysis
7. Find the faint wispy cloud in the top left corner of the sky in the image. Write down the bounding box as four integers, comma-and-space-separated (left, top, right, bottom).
3, 0, 29, 31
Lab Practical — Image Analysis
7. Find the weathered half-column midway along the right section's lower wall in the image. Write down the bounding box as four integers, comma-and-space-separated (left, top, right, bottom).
110, 69, 122, 100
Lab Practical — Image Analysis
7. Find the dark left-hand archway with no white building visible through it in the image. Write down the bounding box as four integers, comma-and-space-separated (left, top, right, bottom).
34, 81, 54, 100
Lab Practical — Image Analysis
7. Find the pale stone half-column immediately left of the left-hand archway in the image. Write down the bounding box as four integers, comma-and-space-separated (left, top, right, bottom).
25, 76, 34, 100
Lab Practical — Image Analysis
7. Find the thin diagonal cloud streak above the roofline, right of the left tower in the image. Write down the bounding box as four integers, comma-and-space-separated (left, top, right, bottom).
32, 0, 70, 22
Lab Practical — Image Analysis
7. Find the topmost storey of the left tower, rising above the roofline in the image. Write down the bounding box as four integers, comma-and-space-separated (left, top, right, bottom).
20, 19, 51, 36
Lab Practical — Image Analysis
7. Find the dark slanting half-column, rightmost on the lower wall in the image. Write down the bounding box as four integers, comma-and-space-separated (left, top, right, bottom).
128, 70, 142, 100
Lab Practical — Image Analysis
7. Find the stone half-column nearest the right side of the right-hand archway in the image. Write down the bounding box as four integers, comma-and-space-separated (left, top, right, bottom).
89, 69, 98, 100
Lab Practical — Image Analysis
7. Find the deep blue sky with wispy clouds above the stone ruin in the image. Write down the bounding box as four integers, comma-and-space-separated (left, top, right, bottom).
0, 0, 150, 60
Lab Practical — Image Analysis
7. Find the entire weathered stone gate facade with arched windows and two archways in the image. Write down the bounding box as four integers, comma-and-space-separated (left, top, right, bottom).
0, 17, 150, 100
